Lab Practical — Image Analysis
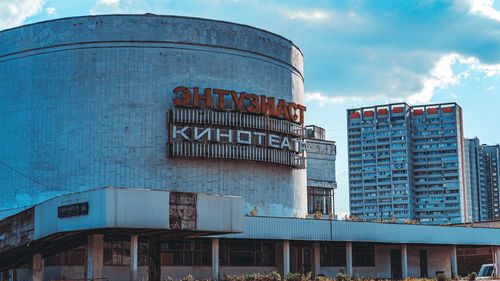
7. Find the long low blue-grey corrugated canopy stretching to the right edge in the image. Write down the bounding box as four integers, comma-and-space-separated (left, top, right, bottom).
219, 217, 500, 245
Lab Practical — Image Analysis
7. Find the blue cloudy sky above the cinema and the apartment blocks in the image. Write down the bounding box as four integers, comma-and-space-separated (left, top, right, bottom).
0, 0, 500, 214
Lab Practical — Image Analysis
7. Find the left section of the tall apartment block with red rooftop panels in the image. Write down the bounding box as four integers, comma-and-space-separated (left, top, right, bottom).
348, 104, 414, 220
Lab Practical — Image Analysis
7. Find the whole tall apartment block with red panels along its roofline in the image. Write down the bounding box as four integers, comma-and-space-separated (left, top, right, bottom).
347, 103, 468, 224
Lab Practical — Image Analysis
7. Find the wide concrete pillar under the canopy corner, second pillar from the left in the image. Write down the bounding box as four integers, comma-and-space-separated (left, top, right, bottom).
87, 234, 104, 280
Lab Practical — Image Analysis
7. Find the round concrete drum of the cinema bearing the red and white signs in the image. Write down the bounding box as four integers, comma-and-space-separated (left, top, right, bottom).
0, 15, 307, 216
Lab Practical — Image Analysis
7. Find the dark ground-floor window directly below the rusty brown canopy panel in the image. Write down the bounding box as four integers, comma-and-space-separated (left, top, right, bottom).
161, 240, 212, 266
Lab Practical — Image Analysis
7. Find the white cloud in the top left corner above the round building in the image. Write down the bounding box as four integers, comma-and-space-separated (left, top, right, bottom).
0, 0, 43, 30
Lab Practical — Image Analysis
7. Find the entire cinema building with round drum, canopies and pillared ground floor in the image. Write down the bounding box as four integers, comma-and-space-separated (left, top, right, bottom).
0, 15, 500, 281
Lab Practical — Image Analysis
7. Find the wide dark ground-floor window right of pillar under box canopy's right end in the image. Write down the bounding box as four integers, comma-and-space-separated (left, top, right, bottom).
220, 240, 276, 266
